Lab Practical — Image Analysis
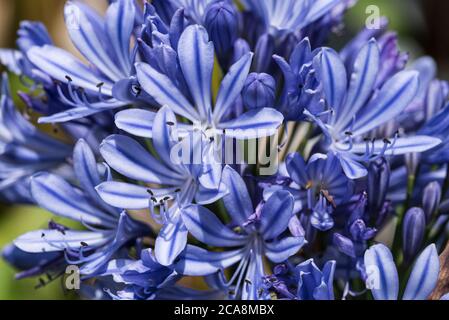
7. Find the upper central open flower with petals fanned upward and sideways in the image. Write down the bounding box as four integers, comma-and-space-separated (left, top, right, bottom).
130, 25, 283, 139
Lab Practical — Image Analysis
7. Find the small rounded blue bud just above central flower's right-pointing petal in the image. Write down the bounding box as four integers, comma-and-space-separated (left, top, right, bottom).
242, 73, 276, 109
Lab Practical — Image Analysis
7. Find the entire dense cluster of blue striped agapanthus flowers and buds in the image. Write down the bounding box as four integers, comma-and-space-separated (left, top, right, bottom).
0, 0, 449, 300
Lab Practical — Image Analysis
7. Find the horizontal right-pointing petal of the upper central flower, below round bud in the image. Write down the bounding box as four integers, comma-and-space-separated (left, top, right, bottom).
217, 108, 284, 140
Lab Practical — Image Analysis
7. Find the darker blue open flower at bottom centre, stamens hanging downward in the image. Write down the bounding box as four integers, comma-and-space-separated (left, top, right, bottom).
176, 167, 305, 299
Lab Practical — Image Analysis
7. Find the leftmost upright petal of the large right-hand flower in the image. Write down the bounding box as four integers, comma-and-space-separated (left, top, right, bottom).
319, 48, 348, 114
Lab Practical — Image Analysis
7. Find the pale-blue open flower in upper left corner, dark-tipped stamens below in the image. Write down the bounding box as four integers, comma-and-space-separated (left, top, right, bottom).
26, 0, 137, 123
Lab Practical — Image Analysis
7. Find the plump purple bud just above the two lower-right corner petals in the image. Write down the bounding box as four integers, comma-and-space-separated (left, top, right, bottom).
402, 207, 426, 262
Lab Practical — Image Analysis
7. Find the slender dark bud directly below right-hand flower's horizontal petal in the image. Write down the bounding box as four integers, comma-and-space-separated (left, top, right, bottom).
367, 158, 390, 217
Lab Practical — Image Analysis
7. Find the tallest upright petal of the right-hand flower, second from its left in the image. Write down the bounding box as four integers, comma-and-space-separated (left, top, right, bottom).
334, 39, 380, 130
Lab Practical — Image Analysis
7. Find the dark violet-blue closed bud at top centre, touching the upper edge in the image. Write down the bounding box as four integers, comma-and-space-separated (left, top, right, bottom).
205, 1, 239, 57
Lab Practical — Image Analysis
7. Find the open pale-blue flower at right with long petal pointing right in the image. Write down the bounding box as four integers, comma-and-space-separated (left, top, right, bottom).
305, 39, 441, 179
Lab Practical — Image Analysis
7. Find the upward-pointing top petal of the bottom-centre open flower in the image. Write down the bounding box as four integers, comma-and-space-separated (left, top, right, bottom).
222, 166, 254, 226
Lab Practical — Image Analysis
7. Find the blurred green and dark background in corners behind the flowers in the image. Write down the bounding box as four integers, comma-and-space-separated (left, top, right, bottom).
0, 0, 449, 300
